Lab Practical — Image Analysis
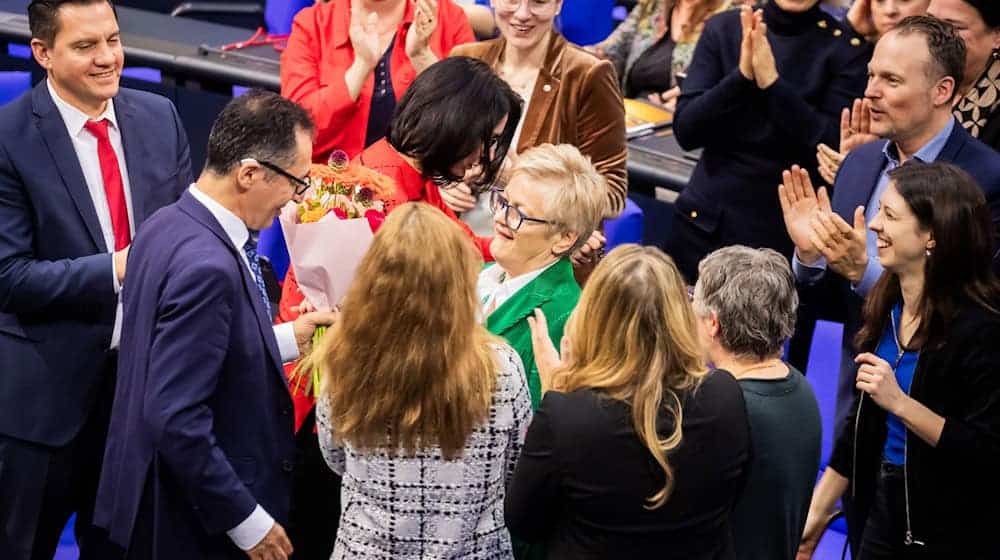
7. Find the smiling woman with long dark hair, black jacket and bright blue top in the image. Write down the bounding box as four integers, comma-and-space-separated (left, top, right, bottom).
800, 162, 1000, 560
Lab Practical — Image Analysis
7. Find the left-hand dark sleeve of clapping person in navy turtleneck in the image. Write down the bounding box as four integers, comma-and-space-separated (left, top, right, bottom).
673, 20, 759, 150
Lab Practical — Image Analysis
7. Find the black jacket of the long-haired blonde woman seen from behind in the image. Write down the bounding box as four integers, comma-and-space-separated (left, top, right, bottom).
504, 371, 751, 560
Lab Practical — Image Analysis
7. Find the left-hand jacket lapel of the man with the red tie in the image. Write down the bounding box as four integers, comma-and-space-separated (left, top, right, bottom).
31, 80, 106, 252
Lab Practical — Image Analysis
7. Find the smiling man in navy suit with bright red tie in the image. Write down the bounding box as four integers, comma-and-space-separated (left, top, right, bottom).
0, 0, 191, 560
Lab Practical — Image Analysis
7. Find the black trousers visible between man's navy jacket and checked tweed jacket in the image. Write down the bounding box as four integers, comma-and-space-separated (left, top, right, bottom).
288, 407, 340, 560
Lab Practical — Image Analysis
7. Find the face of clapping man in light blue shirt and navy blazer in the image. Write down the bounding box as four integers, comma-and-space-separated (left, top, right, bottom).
865, 32, 953, 143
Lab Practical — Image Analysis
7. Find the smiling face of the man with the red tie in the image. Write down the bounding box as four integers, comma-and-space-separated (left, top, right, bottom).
31, 2, 125, 116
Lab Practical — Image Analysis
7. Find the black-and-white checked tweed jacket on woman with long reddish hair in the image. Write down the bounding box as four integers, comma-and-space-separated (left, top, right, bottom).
316, 344, 531, 560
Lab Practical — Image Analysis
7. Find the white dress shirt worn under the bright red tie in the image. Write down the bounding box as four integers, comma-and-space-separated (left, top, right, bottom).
45, 80, 135, 349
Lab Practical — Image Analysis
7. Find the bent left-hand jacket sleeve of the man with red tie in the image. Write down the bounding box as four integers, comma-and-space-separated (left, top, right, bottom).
0, 142, 115, 313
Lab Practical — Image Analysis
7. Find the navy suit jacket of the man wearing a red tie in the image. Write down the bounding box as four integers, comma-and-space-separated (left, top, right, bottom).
0, 81, 191, 446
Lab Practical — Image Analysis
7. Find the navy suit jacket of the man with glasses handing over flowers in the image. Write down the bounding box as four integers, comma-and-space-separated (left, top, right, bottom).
94, 192, 294, 560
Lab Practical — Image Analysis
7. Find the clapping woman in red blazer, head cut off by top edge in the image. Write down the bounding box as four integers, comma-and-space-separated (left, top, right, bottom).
281, 0, 475, 162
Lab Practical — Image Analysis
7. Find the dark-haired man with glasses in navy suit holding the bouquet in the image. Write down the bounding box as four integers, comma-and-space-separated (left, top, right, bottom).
94, 91, 333, 560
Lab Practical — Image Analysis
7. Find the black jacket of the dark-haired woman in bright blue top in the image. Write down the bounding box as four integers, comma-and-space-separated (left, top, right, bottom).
830, 305, 1000, 560
